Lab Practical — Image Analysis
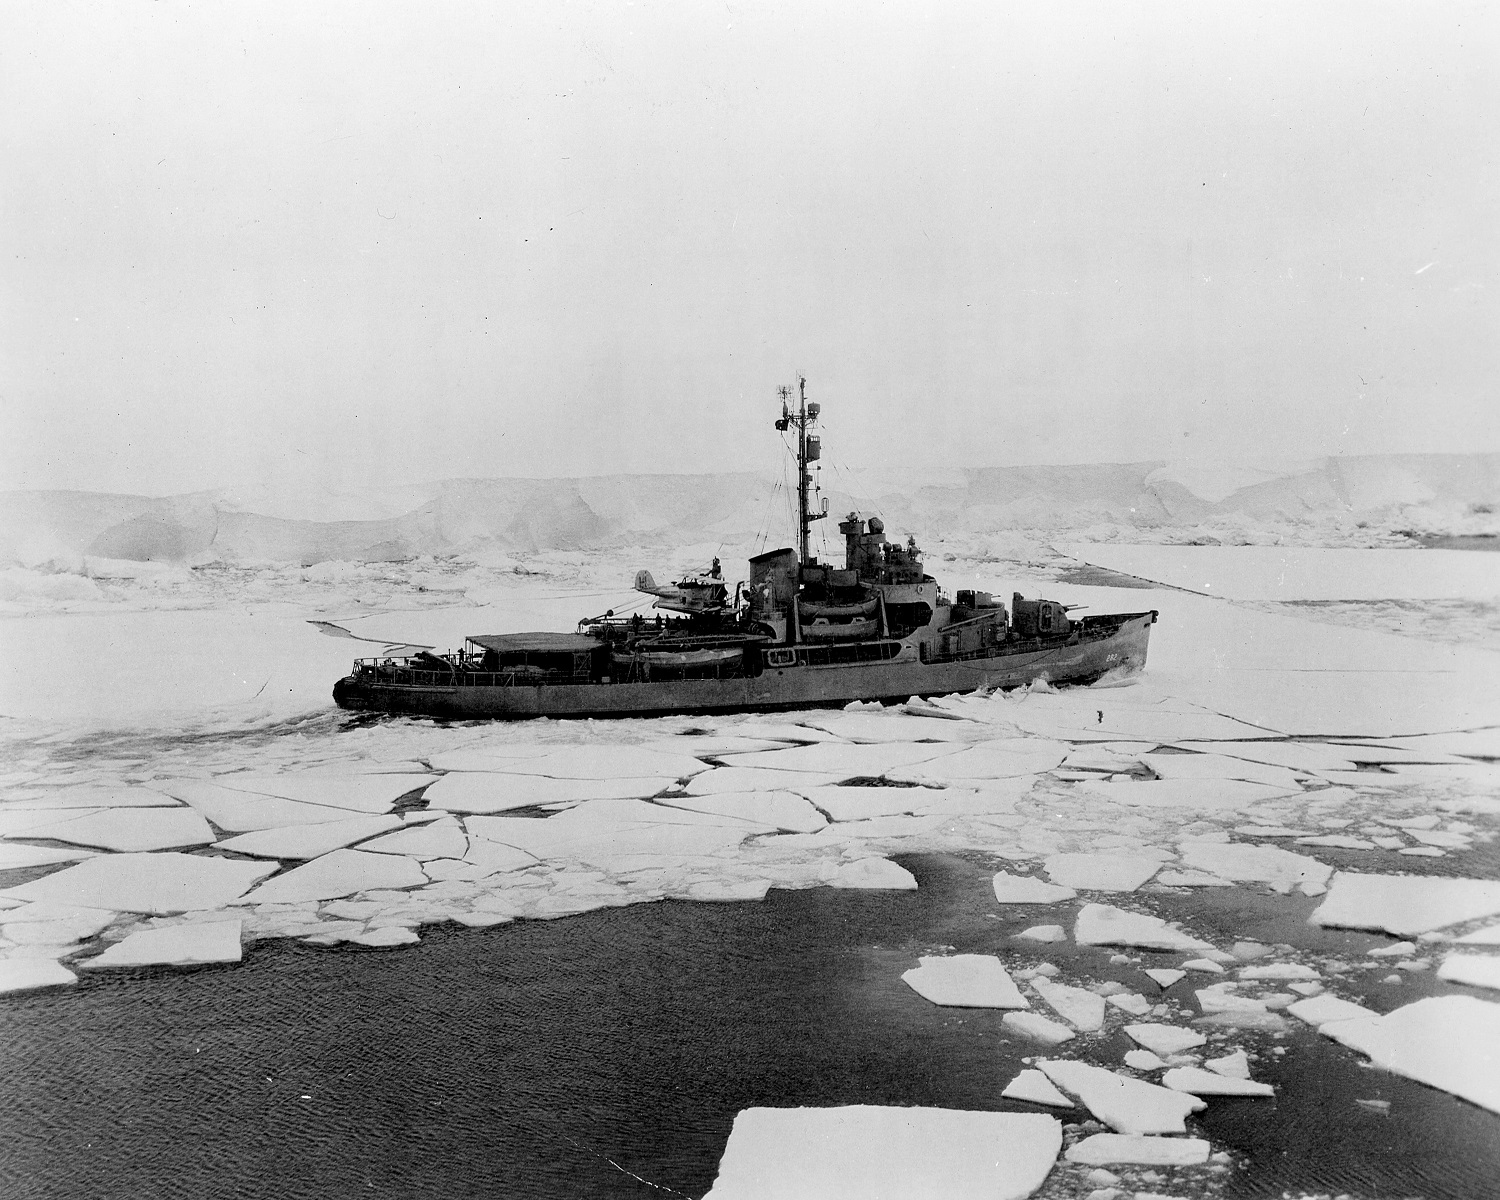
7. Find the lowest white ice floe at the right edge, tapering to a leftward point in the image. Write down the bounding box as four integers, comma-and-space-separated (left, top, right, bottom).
1319, 996, 1500, 1113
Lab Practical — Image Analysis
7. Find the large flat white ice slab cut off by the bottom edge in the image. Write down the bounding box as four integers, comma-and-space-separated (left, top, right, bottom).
705, 1104, 1062, 1200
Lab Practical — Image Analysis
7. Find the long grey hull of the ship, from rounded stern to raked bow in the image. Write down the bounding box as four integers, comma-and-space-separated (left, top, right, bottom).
333, 612, 1155, 720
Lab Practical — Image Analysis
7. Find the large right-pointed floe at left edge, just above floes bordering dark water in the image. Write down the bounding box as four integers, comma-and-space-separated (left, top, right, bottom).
3, 851, 276, 914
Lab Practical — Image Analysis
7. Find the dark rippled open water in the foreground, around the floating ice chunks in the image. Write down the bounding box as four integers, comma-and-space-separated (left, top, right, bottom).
0, 857, 1500, 1200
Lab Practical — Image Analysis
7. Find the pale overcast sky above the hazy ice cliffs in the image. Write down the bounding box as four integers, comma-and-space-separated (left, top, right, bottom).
0, 0, 1500, 494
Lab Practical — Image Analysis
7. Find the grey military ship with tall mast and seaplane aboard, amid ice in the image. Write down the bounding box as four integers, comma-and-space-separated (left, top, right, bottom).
333, 378, 1157, 720
